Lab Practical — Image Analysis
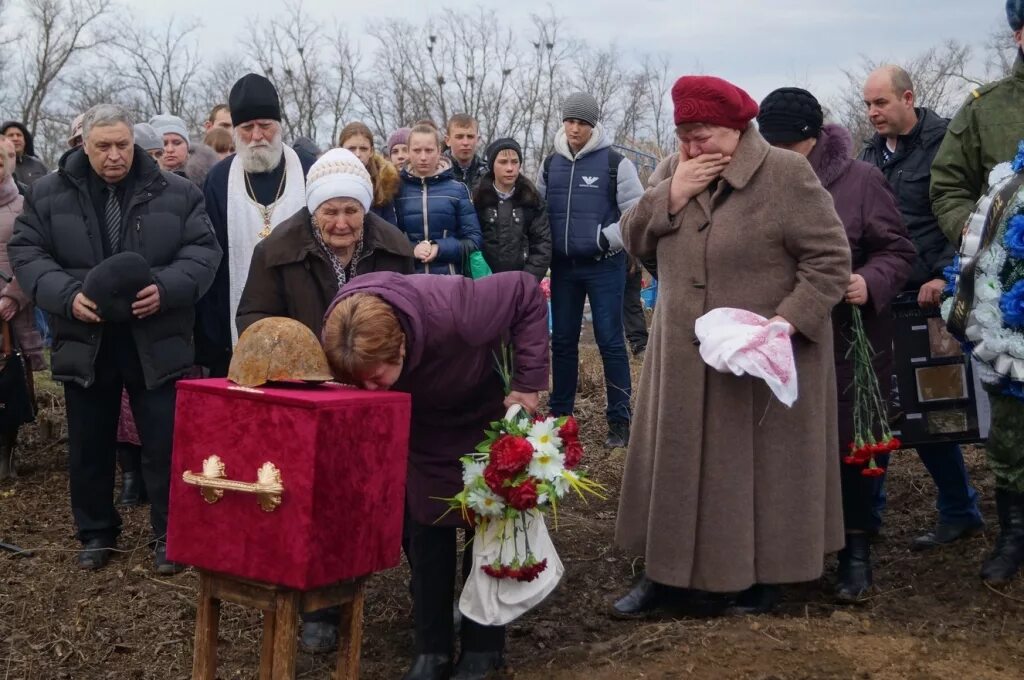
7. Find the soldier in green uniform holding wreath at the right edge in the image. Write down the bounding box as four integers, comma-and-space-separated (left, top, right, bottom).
931, 0, 1024, 584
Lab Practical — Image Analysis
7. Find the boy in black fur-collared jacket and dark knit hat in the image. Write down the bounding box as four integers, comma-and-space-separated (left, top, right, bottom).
473, 138, 551, 281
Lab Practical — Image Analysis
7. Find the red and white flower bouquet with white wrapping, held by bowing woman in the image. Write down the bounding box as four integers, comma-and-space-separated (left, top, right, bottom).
446, 406, 604, 626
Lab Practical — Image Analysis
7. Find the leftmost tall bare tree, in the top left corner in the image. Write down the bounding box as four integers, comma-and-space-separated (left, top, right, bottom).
16, 0, 112, 134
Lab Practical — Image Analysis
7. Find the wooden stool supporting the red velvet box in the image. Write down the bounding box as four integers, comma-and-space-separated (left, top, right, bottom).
193, 569, 366, 680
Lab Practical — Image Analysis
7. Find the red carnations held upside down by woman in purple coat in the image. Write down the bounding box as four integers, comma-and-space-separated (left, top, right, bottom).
843, 304, 900, 477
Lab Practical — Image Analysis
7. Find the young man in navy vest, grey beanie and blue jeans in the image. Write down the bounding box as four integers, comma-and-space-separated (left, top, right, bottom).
537, 92, 643, 448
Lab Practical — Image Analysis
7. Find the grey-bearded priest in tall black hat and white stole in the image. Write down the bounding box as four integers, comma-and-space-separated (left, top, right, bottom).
196, 74, 316, 377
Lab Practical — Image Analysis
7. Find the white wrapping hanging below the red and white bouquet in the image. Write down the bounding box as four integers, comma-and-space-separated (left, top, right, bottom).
459, 510, 565, 626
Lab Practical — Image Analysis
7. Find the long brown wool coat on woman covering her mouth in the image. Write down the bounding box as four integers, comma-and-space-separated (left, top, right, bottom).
615, 126, 850, 592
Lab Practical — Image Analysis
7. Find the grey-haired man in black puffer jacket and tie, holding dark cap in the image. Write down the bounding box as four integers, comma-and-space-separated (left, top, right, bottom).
8, 104, 220, 573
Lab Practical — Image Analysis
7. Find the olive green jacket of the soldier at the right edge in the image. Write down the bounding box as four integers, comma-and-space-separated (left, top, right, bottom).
931, 53, 1024, 244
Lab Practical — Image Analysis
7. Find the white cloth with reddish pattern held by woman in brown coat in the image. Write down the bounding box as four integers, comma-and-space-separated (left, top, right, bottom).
693, 307, 797, 407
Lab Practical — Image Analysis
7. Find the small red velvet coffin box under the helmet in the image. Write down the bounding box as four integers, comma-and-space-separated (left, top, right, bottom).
167, 379, 411, 590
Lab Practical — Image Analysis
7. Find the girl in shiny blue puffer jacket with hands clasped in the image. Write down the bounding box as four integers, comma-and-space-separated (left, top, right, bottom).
394, 125, 483, 274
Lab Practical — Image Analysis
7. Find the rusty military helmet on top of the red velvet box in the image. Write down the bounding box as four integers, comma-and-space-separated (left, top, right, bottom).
227, 316, 333, 387
